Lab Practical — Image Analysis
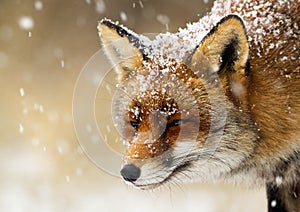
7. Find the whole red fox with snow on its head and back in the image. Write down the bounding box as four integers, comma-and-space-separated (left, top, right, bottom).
98, 0, 300, 211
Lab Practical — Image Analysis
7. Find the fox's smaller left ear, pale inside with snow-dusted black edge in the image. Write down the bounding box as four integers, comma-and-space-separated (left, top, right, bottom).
98, 19, 146, 82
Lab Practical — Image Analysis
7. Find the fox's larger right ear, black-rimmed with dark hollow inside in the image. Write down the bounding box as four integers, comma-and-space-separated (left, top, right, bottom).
192, 15, 249, 74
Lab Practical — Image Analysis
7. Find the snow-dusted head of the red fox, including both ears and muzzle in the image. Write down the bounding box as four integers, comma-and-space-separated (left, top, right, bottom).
98, 15, 257, 189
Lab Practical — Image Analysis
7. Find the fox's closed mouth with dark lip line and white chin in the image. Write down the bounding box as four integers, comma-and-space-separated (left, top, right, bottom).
133, 162, 191, 190
